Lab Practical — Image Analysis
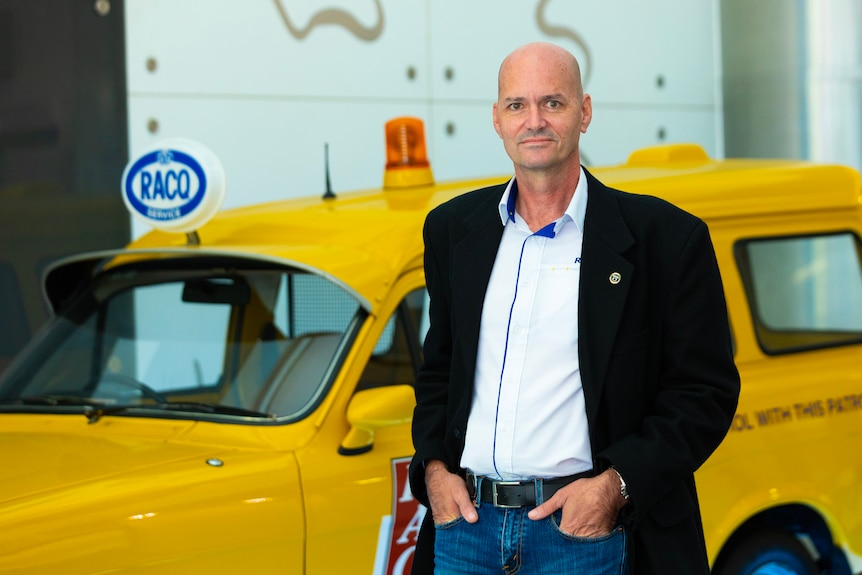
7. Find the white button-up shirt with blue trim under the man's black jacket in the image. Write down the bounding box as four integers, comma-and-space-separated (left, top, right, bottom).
461, 169, 593, 480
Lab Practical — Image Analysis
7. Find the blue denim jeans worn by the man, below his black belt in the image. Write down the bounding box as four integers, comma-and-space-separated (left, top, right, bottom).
434, 503, 629, 575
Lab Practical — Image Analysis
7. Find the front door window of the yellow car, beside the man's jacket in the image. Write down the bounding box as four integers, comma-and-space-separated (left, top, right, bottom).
356, 288, 427, 391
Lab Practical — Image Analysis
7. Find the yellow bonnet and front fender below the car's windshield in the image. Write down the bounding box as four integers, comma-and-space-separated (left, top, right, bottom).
0, 415, 305, 573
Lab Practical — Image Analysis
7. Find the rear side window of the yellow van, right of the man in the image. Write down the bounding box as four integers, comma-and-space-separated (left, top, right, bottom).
736, 232, 862, 354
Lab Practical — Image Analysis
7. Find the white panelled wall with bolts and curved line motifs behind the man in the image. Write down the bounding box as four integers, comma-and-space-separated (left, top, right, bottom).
126, 0, 722, 235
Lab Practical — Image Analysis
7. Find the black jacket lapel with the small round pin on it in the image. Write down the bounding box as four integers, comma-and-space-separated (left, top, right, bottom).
578, 170, 635, 429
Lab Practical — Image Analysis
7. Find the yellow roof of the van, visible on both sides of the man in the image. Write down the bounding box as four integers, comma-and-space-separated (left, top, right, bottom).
104, 144, 860, 311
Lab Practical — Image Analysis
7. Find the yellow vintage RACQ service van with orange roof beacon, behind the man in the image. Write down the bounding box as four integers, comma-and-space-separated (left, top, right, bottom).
0, 118, 862, 575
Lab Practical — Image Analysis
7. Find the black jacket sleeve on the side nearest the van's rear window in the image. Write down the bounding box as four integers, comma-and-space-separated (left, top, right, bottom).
597, 222, 740, 522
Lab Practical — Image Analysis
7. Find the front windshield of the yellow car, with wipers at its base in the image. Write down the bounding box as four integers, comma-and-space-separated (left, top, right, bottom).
0, 263, 364, 422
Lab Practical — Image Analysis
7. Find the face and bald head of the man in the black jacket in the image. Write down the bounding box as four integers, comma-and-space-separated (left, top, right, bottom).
494, 51, 592, 173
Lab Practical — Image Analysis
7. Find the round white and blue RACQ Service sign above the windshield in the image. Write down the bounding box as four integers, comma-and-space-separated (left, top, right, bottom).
122, 138, 225, 232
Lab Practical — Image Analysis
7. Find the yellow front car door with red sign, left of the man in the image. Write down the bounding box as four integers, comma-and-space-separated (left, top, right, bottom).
297, 270, 427, 575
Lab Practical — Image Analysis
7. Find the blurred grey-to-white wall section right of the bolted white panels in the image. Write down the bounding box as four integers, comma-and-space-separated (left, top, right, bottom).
720, 0, 862, 170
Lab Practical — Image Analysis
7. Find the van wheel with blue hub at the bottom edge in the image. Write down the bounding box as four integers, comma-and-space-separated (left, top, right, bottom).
714, 529, 820, 575
